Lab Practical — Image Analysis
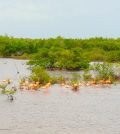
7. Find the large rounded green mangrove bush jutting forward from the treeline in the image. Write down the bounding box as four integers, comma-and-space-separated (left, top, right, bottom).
29, 47, 89, 70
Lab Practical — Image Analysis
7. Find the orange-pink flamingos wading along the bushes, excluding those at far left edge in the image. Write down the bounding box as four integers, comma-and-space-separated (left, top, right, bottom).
19, 79, 112, 91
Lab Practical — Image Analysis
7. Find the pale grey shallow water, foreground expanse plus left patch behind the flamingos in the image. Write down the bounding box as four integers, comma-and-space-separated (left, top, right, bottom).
0, 59, 120, 134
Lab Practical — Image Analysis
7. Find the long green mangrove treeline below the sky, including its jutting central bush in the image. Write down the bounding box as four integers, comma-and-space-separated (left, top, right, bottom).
0, 36, 120, 70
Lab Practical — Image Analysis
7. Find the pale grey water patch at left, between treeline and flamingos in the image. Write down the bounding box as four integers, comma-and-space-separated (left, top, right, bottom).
0, 58, 30, 82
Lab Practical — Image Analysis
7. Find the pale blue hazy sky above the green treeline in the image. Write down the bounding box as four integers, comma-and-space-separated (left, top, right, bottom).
0, 0, 120, 38
